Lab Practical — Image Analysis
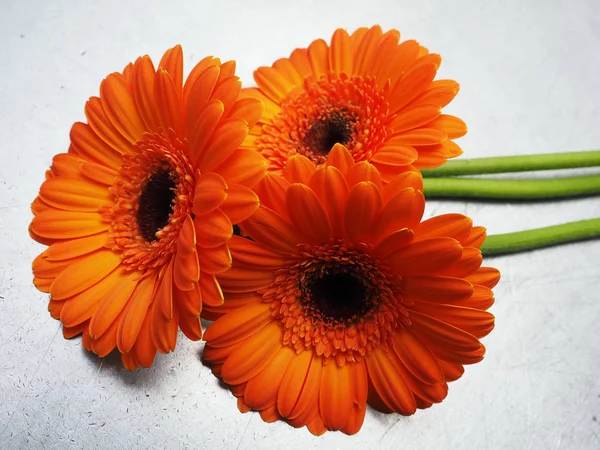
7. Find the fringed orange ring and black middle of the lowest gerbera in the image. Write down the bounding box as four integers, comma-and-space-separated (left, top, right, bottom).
263, 239, 409, 366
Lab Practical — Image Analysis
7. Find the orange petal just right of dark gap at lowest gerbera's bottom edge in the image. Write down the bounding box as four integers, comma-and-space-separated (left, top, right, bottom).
365, 347, 417, 416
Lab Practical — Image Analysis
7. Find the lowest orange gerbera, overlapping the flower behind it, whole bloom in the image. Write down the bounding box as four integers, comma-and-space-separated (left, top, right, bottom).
204, 145, 499, 434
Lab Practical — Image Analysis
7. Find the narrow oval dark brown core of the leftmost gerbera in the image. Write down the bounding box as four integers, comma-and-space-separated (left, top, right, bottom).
136, 167, 177, 242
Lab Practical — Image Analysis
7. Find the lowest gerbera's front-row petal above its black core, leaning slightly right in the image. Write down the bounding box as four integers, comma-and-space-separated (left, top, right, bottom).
344, 182, 382, 240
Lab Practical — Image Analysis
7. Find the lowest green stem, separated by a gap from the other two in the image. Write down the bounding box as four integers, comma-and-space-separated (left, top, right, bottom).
481, 219, 600, 256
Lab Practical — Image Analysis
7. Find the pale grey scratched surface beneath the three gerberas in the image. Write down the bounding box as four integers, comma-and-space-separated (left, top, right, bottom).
0, 0, 600, 450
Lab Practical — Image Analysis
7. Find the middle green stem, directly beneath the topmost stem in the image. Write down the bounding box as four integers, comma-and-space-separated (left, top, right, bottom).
423, 175, 600, 200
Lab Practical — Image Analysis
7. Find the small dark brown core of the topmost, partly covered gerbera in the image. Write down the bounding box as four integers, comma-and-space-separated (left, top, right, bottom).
303, 111, 355, 156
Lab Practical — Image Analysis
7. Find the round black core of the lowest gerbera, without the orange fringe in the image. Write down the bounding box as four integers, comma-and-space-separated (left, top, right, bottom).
304, 272, 373, 322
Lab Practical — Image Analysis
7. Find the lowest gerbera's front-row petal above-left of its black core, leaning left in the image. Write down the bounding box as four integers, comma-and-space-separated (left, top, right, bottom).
286, 183, 331, 243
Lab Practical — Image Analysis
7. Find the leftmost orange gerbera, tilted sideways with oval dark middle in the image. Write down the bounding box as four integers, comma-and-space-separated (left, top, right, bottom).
30, 46, 266, 370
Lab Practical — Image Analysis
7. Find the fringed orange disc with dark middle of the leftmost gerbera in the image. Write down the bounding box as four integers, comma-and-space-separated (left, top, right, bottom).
102, 132, 194, 270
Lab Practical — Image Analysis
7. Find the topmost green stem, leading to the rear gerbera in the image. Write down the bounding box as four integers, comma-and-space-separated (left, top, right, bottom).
422, 150, 600, 178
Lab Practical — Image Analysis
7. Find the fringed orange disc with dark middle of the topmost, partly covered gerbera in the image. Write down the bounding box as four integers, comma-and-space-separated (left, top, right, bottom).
256, 74, 391, 171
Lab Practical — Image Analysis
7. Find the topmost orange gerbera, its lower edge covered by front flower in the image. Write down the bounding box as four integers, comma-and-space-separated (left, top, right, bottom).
242, 26, 467, 181
